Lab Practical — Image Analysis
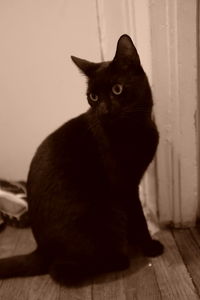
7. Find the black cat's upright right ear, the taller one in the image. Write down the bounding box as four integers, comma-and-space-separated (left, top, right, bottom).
114, 34, 140, 64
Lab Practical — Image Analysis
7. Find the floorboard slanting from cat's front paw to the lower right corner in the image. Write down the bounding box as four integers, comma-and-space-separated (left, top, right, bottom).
152, 230, 199, 300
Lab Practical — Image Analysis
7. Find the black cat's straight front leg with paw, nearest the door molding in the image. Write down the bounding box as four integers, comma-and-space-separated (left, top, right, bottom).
128, 192, 164, 257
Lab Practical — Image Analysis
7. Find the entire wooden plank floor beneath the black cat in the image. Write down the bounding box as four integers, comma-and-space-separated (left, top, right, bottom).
0, 227, 200, 300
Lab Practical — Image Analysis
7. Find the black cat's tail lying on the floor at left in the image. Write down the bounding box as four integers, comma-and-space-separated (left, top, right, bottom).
0, 250, 48, 279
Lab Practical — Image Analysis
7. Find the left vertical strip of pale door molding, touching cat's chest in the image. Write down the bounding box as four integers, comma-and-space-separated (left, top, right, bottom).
149, 0, 173, 223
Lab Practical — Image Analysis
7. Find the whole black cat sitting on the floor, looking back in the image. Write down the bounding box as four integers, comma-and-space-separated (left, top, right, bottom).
0, 35, 163, 285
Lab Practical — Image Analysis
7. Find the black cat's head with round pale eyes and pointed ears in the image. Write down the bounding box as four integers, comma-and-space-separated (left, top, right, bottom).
71, 34, 152, 117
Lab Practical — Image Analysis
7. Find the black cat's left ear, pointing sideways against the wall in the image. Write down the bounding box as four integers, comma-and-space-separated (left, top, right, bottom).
71, 56, 99, 77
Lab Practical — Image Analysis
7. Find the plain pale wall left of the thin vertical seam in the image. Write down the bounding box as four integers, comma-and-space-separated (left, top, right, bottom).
0, 0, 100, 180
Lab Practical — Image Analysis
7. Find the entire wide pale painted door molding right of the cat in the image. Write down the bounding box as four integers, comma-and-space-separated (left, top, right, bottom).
150, 0, 198, 227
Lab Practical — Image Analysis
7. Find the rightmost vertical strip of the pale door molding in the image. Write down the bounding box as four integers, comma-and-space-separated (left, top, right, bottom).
177, 0, 198, 225
